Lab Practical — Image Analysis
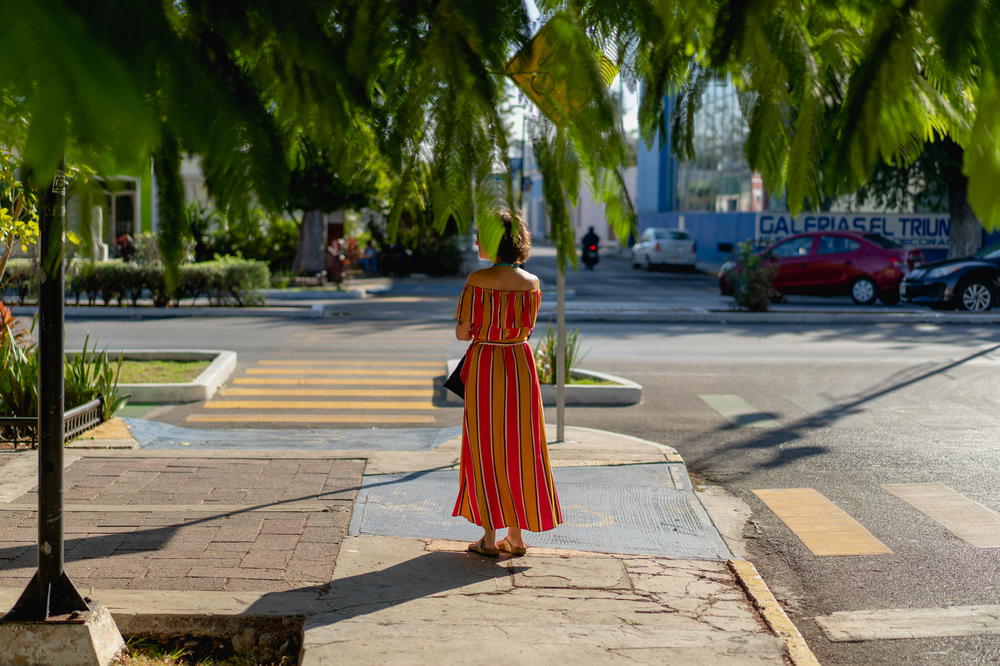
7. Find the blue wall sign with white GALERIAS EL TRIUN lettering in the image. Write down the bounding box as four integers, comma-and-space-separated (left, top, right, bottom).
754, 213, 951, 247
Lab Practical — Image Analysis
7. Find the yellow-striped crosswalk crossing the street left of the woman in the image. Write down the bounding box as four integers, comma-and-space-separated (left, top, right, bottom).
186, 326, 454, 427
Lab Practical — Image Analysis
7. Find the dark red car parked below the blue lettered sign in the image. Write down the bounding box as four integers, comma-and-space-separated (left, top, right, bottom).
719, 231, 922, 305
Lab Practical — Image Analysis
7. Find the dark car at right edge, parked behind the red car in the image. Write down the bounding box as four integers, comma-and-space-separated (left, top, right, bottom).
899, 243, 1000, 312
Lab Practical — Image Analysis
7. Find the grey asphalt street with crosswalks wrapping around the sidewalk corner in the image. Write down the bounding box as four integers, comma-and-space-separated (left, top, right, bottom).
66, 252, 1000, 664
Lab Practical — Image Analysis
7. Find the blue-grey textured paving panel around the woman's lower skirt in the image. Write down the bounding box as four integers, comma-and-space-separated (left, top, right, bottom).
351, 464, 731, 559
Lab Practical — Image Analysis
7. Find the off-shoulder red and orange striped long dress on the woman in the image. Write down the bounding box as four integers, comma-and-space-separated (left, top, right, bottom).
452, 284, 562, 532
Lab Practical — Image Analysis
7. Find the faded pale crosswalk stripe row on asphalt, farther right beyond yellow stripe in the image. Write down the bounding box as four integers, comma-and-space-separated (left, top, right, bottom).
697, 393, 1000, 429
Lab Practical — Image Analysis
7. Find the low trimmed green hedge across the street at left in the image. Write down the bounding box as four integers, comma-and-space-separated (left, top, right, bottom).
0, 257, 271, 307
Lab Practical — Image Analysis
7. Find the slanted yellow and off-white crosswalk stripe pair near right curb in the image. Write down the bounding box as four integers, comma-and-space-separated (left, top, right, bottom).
752, 482, 1000, 557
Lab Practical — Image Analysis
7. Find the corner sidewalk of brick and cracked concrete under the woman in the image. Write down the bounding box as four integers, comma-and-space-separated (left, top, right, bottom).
0, 428, 815, 665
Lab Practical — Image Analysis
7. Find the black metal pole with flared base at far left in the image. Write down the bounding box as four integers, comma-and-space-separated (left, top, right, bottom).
4, 162, 90, 621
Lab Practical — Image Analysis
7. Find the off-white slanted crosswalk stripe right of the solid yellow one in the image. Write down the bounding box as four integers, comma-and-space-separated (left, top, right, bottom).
882, 483, 1000, 548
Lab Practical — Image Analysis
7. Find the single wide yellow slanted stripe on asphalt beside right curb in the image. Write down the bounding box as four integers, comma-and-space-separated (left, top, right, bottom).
753, 488, 892, 556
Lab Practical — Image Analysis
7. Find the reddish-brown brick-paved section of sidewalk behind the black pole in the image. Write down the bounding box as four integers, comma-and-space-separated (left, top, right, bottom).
0, 456, 364, 592
